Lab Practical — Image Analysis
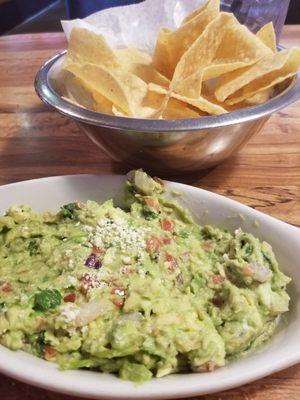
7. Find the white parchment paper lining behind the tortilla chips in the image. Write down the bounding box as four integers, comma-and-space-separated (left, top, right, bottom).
61, 0, 206, 54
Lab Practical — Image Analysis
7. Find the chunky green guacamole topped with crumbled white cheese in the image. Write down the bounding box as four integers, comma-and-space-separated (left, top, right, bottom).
0, 171, 290, 382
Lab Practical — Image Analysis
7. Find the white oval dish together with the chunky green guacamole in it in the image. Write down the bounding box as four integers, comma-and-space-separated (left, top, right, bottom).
0, 171, 300, 398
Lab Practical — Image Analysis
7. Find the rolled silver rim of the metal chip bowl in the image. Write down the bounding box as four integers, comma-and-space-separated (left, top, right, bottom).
34, 46, 300, 133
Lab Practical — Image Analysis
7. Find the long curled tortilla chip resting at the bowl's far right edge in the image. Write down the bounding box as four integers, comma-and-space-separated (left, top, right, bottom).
215, 47, 300, 104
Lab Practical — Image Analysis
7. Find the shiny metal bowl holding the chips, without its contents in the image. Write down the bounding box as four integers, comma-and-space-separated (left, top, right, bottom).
35, 51, 300, 176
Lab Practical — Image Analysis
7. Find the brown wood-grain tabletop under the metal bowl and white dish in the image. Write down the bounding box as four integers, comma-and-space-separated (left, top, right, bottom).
0, 26, 300, 400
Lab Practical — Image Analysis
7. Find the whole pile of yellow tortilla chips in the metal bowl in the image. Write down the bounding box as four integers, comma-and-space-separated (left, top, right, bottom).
63, 0, 300, 119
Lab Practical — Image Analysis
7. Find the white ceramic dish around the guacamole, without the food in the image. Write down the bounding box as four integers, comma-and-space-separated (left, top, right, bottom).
0, 175, 300, 399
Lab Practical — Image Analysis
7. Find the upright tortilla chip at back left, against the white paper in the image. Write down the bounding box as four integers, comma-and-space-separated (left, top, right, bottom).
64, 28, 120, 68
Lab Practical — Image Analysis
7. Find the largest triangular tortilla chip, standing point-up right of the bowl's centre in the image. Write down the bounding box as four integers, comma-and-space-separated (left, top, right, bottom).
173, 12, 271, 82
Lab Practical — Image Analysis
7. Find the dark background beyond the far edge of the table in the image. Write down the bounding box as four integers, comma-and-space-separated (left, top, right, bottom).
0, 0, 300, 35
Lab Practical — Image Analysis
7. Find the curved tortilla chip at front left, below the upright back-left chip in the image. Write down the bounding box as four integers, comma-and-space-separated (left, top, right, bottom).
67, 64, 148, 116
